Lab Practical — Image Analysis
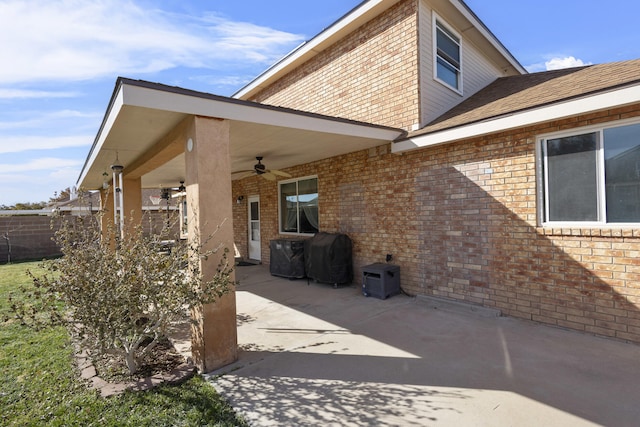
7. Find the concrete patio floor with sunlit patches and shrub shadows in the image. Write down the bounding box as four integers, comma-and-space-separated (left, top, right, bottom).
206, 266, 640, 426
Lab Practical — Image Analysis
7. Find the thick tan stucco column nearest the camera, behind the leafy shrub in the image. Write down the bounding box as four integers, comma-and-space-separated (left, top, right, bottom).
185, 117, 238, 372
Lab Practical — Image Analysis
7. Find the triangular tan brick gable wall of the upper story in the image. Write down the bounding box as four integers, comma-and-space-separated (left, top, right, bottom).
251, 0, 420, 129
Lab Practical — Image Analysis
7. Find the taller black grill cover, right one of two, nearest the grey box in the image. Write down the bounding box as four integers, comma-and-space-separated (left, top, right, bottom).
304, 233, 353, 285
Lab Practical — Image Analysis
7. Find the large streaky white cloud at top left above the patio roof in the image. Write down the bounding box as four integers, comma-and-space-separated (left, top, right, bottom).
0, 0, 302, 85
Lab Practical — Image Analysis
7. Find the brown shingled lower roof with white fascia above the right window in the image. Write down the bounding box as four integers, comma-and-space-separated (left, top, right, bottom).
394, 60, 640, 152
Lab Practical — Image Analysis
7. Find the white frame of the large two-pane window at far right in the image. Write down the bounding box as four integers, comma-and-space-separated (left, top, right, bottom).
536, 118, 640, 228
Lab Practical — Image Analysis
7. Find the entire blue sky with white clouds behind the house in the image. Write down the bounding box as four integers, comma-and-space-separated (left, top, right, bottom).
0, 0, 640, 205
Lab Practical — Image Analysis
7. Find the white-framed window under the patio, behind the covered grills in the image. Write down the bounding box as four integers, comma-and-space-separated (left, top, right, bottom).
278, 177, 318, 234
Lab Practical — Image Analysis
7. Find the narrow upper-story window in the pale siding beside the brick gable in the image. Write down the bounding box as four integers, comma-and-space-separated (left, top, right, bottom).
433, 14, 462, 93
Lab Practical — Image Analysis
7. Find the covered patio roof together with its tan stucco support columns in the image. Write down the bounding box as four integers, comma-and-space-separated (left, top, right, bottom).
77, 78, 403, 372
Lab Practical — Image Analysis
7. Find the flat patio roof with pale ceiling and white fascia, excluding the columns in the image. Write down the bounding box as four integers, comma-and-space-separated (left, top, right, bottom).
77, 78, 404, 190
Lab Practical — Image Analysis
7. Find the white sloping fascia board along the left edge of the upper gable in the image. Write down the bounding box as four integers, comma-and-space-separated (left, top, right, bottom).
232, 0, 400, 99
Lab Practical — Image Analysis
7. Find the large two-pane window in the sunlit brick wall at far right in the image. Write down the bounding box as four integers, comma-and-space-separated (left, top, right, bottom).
540, 123, 640, 224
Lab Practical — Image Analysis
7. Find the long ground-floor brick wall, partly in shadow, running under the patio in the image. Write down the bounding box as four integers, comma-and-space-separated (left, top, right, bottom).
233, 104, 640, 342
